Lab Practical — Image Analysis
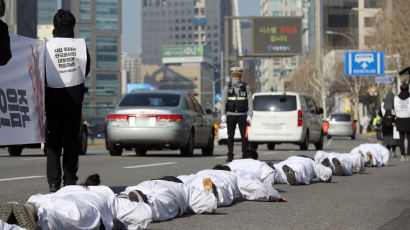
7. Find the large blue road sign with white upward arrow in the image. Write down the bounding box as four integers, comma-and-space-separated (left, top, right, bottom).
345, 52, 384, 76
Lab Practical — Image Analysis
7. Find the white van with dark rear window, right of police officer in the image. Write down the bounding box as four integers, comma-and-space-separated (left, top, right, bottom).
248, 92, 324, 150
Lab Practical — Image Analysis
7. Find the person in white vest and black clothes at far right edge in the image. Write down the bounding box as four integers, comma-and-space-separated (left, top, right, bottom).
394, 83, 410, 161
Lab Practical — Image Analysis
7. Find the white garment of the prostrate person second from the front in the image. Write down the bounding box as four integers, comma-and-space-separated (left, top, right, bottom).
123, 180, 217, 221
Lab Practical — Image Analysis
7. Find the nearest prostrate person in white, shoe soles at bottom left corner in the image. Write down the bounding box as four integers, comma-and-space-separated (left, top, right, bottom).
0, 174, 152, 230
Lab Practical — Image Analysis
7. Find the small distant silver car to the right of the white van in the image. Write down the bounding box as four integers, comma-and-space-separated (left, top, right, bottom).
327, 113, 356, 140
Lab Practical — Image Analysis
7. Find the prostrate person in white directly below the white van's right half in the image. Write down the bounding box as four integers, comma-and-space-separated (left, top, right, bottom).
274, 156, 332, 185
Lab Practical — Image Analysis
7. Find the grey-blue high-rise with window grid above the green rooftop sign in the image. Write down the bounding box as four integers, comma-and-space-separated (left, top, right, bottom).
141, 0, 230, 66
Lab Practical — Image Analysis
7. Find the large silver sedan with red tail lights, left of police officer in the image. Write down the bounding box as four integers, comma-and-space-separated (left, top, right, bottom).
106, 90, 214, 156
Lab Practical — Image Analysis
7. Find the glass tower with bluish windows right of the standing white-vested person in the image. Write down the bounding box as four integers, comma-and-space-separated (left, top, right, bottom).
62, 0, 121, 121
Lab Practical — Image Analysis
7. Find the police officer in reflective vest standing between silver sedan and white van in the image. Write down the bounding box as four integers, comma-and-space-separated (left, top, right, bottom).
221, 67, 253, 162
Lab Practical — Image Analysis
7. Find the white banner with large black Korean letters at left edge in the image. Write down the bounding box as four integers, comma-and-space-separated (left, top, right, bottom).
0, 35, 45, 145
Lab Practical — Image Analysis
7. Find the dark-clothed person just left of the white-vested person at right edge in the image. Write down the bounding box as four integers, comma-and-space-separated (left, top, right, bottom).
379, 92, 399, 157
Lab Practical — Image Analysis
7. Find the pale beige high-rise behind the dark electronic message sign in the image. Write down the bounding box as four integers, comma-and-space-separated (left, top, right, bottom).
260, 0, 311, 91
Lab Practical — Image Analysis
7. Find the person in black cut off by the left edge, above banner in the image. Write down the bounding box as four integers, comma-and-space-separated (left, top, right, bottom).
0, 0, 11, 66
